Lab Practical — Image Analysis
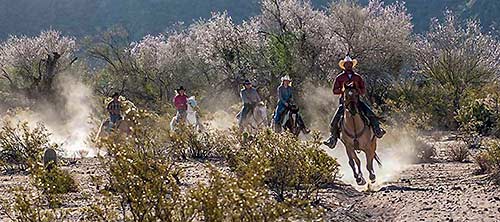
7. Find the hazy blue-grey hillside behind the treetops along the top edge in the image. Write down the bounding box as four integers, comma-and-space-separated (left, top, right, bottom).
0, 0, 500, 39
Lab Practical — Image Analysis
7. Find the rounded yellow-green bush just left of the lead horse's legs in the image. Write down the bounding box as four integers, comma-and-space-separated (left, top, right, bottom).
229, 130, 339, 201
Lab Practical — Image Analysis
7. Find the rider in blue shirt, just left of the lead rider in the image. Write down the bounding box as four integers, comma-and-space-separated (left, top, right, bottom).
274, 75, 310, 134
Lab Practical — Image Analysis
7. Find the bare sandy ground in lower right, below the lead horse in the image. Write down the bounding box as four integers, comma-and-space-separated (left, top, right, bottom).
324, 133, 500, 221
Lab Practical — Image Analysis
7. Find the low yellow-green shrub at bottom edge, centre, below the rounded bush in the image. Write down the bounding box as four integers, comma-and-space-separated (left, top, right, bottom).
190, 169, 313, 221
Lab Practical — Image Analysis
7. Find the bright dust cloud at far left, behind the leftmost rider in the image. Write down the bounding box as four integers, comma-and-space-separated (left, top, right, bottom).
4, 73, 96, 158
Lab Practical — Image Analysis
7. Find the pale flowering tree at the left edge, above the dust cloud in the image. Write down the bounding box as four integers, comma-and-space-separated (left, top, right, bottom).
0, 30, 76, 103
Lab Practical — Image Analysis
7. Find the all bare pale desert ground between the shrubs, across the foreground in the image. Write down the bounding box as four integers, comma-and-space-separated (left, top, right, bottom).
0, 130, 500, 221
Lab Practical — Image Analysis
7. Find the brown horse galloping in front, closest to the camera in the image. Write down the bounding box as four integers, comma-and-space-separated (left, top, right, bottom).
340, 83, 382, 186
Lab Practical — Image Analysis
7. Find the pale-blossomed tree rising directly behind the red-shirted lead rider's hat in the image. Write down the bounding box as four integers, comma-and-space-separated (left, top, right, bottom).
328, 0, 413, 102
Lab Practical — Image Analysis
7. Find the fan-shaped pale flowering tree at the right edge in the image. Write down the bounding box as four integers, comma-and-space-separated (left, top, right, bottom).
415, 12, 500, 113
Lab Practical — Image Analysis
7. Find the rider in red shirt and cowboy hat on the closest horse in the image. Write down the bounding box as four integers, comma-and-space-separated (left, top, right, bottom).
323, 55, 385, 149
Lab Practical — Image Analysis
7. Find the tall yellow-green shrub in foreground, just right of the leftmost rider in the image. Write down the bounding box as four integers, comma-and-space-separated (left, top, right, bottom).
96, 110, 192, 221
